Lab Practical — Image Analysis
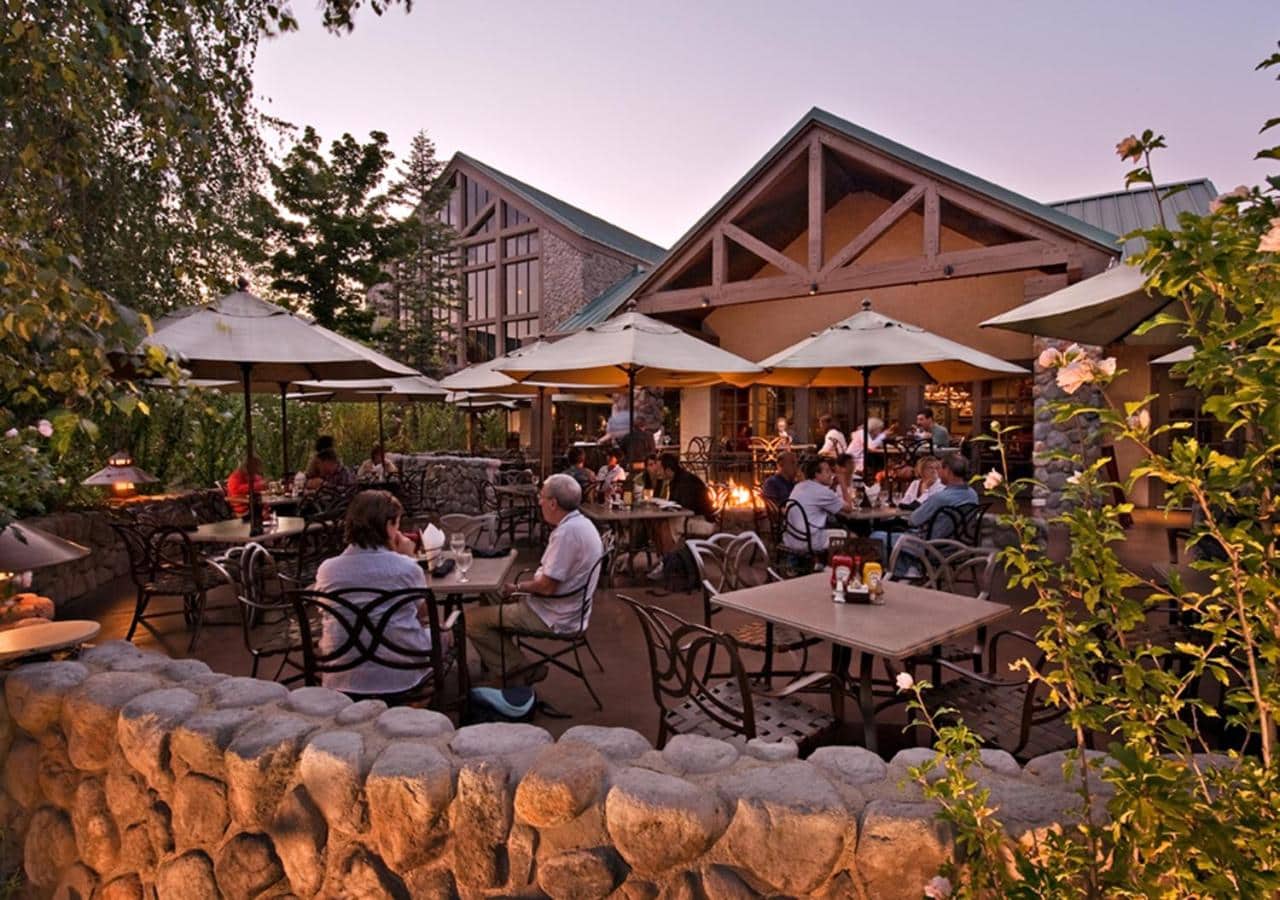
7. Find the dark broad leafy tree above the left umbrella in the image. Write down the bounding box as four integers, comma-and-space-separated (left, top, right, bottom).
246, 127, 410, 339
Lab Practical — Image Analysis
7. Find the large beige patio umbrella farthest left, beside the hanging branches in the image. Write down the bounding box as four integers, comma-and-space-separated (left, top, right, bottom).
142, 285, 401, 532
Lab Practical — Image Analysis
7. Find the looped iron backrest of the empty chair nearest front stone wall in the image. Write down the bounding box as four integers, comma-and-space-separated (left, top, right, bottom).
618, 594, 755, 739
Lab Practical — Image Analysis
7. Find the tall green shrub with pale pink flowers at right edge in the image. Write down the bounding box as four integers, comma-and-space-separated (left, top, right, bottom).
916, 55, 1280, 897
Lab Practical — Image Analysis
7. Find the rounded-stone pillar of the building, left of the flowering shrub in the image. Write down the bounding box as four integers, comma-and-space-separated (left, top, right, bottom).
1032, 337, 1101, 516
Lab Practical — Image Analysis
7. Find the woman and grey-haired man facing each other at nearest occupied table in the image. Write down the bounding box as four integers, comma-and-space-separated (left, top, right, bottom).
307, 474, 604, 696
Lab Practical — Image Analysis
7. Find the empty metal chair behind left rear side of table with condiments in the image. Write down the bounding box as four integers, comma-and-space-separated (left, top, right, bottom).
685, 531, 819, 685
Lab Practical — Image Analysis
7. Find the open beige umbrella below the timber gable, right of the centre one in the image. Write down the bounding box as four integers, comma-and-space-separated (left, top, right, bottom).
756, 300, 1028, 466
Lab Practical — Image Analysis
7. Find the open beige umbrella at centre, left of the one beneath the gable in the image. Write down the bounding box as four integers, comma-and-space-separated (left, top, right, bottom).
495, 311, 763, 462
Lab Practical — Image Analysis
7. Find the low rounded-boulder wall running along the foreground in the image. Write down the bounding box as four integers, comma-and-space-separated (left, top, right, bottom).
0, 641, 1131, 900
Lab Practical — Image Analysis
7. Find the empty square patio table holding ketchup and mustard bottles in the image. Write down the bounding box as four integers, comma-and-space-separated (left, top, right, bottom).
714, 572, 1010, 753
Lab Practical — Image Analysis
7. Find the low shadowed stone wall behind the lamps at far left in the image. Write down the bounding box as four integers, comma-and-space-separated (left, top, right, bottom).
23, 492, 227, 606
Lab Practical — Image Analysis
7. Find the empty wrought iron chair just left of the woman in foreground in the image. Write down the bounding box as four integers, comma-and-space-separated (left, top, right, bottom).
212, 543, 302, 684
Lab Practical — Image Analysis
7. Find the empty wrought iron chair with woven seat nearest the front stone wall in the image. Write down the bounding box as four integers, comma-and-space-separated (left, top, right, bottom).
618, 594, 836, 750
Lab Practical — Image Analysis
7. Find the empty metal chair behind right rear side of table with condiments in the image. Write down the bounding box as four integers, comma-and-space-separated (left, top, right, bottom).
888, 534, 997, 684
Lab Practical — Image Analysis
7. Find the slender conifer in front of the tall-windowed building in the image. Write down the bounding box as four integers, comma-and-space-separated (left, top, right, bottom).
379, 132, 458, 373
